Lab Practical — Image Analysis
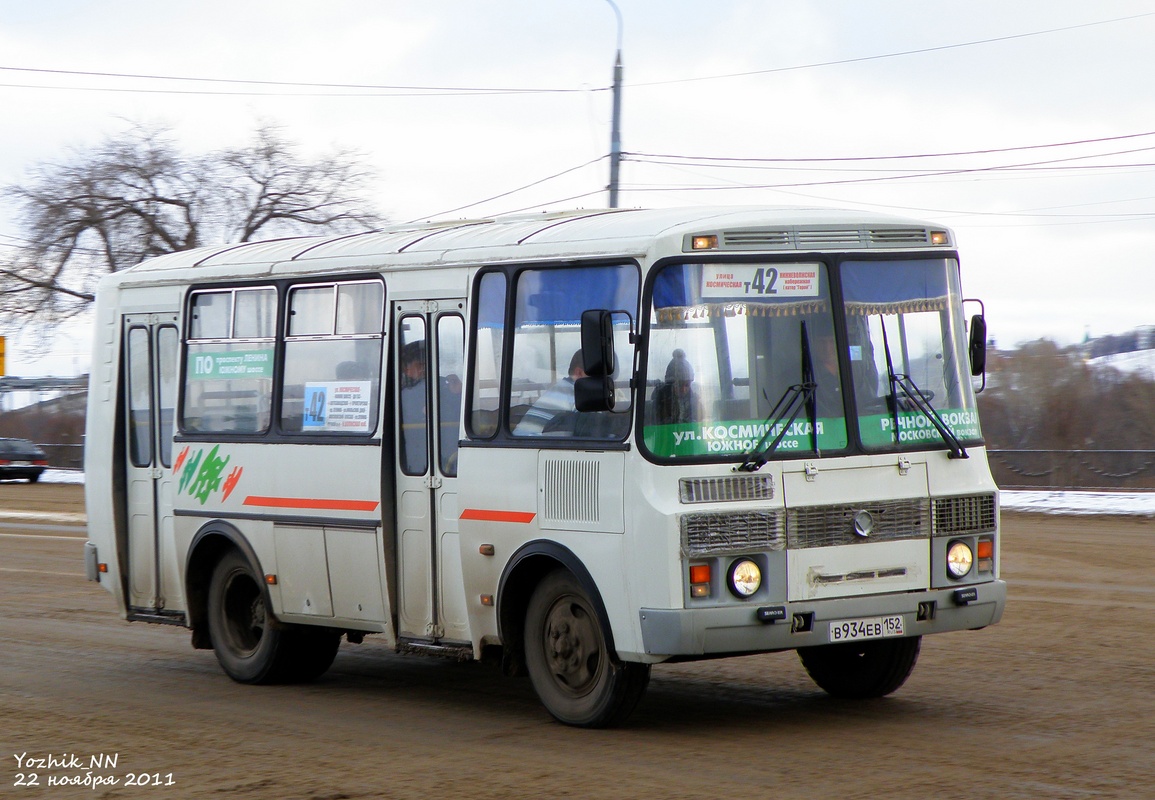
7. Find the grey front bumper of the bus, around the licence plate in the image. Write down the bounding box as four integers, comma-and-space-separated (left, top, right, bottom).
641, 581, 1007, 660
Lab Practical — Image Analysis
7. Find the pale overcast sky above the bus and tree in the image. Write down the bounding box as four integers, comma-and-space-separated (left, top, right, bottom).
0, 0, 1155, 375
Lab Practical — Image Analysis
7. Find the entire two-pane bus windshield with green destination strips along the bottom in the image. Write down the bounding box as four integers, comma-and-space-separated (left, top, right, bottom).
642, 259, 981, 461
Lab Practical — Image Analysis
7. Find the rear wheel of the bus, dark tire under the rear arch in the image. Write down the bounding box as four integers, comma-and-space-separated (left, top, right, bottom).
208, 551, 341, 683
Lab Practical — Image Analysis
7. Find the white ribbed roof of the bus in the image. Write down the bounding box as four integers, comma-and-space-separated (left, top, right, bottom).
110, 205, 953, 279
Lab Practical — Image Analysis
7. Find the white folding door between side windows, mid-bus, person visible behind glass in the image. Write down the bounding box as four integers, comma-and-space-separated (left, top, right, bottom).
393, 300, 469, 643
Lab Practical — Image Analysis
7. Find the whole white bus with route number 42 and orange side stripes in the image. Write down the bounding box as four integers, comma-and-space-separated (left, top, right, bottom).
85, 208, 1006, 726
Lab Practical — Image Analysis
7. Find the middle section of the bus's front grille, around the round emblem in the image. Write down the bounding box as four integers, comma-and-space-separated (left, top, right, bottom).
787, 499, 931, 548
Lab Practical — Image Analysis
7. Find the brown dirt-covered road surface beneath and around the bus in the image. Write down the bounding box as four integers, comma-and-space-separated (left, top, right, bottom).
0, 484, 1155, 800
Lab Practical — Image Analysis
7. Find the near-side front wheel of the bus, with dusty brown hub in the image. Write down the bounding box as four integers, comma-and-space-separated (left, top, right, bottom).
526, 569, 650, 727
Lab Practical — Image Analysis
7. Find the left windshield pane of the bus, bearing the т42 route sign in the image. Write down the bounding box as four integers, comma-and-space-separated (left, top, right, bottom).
642, 262, 849, 458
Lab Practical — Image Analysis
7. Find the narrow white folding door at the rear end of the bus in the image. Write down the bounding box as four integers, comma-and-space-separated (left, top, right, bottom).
120, 313, 180, 612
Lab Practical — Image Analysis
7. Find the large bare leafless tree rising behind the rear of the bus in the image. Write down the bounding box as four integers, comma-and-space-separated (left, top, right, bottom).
0, 126, 381, 328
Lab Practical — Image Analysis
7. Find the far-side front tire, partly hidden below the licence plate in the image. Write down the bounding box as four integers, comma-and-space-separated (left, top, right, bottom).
798, 636, 923, 700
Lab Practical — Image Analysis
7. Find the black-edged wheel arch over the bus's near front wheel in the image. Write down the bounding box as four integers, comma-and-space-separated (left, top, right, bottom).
497, 540, 617, 674
